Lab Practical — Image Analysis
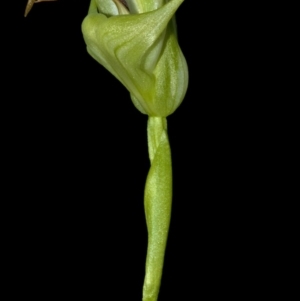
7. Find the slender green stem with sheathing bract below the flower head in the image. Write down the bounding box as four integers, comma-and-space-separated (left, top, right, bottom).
143, 117, 172, 301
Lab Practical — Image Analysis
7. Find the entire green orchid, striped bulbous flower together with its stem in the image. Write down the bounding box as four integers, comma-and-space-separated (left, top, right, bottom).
82, 0, 188, 301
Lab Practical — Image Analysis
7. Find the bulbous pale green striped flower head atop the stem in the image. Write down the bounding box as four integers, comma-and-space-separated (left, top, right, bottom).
82, 0, 188, 117
